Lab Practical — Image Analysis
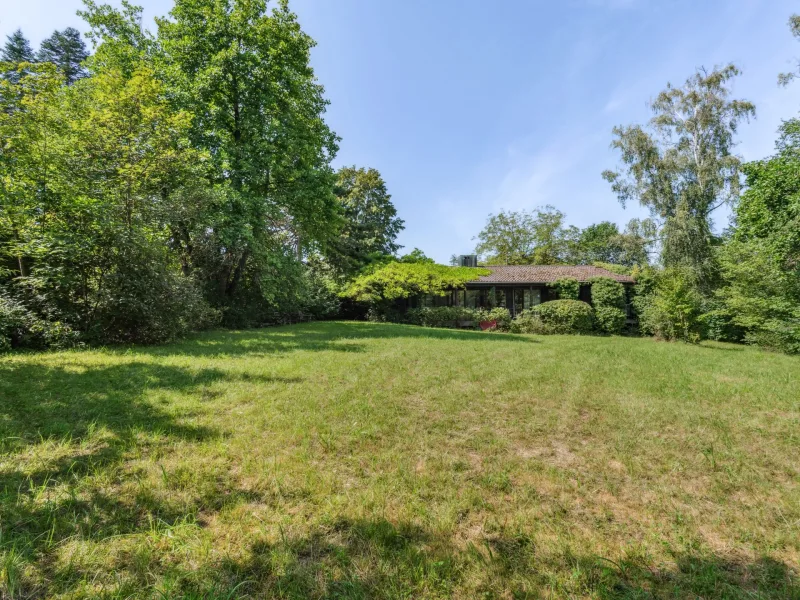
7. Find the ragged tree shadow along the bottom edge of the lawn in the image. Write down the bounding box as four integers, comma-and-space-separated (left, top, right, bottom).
109, 519, 800, 600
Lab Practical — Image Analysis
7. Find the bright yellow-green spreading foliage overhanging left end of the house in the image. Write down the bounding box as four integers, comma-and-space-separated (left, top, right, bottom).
343, 262, 489, 304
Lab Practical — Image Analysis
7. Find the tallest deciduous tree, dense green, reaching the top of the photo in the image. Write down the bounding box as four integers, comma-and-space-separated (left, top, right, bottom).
157, 0, 338, 304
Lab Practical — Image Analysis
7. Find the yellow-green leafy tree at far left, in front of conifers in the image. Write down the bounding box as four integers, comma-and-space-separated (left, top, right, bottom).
0, 64, 215, 343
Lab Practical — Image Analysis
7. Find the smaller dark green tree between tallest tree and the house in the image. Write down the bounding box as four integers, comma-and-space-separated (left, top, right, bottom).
326, 167, 403, 275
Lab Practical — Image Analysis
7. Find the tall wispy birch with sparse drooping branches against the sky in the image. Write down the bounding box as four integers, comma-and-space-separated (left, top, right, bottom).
603, 65, 755, 283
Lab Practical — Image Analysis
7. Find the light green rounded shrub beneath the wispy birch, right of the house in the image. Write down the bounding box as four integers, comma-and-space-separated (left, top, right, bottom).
634, 268, 703, 342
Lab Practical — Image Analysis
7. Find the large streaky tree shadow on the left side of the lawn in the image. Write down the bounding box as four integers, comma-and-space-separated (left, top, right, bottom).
0, 355, 276, 597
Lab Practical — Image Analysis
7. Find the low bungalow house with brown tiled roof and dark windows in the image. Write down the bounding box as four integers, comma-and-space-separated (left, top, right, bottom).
419, 257, 635, 316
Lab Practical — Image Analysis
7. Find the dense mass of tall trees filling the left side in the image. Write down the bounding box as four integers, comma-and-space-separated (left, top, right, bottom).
0, 0, 403, 350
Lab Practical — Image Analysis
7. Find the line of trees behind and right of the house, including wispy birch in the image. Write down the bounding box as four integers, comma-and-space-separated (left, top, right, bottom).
476, 51, 800, 353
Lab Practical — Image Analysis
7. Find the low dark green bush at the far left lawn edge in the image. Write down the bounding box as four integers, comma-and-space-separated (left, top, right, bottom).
0, 293, 80, 352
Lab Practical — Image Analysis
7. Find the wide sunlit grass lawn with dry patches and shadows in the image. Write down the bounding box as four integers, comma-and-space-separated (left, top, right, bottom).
0, 322, 800, 599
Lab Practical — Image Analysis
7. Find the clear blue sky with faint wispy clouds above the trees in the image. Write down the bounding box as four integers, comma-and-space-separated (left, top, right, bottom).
0, 0, 800, 261
